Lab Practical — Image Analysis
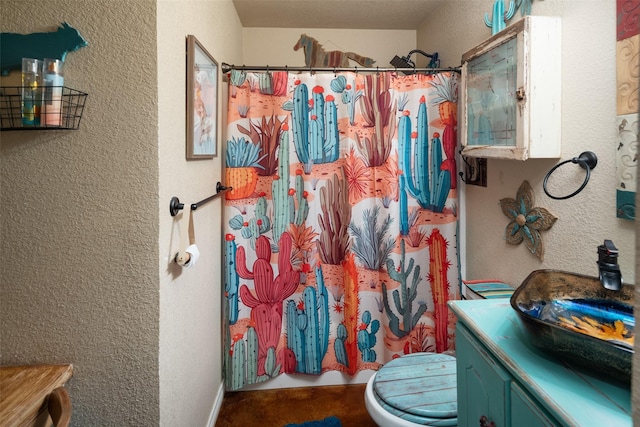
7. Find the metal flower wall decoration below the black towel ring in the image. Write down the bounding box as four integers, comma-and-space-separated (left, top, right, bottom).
500, 181, 558, 261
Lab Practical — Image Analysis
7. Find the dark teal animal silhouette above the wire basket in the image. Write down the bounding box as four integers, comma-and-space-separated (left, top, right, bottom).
0, 22, 88, 76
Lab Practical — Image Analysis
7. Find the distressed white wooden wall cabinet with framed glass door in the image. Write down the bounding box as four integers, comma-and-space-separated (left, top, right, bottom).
460, 16, 561, 160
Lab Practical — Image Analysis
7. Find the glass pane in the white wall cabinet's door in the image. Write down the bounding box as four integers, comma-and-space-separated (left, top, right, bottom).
467, 37, 518, 147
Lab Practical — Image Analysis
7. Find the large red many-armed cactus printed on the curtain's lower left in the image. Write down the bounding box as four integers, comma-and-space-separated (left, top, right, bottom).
236, 233, 300, 375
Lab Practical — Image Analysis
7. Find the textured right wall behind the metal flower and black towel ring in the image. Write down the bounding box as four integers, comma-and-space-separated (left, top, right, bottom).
418, 0, 636, 285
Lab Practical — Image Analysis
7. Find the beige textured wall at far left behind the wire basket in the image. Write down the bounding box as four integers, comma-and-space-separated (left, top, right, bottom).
0, 0, 160, 427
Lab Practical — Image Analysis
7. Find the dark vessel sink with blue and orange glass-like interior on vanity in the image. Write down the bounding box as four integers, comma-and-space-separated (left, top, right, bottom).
511, 270, 635, 382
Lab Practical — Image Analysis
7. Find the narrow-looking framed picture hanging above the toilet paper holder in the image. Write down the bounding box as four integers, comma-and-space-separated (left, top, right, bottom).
186, 35, 219, 160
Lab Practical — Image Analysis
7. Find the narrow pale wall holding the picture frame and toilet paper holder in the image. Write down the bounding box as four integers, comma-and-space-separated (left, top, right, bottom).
158, 0, 242, 427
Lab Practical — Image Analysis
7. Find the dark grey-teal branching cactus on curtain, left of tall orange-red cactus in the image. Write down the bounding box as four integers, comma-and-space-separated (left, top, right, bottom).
382, 239, 427, 338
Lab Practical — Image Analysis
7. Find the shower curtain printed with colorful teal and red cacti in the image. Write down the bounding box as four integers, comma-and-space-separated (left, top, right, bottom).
223, 71, 460, 390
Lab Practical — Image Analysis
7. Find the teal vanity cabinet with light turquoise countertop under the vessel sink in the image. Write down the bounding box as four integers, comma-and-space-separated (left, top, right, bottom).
449, 299, 632, 427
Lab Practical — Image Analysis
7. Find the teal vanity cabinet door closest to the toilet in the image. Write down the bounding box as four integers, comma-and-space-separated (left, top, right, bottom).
456, 322, 511, 427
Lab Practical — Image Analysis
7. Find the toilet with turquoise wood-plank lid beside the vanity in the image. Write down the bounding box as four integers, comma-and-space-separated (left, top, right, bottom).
365, 353, 458, 427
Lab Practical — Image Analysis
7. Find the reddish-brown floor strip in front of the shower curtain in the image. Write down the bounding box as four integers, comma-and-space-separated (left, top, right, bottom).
216, 384, 376, 427
